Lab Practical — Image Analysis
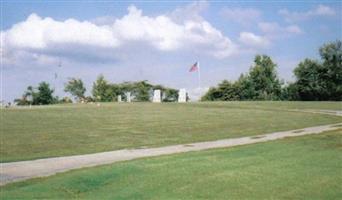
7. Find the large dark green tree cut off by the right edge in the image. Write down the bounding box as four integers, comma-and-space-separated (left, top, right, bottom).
292, 40, 342, 101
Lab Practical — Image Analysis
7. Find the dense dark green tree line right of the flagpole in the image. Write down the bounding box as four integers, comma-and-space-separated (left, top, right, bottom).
201, 40, 342, 101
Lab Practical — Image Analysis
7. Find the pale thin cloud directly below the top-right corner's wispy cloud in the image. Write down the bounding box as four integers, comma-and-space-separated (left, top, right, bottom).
258, 22, 304, 39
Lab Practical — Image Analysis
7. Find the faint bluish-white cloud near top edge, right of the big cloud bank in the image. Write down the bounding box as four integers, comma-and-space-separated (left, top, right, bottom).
220, 8, 262, 25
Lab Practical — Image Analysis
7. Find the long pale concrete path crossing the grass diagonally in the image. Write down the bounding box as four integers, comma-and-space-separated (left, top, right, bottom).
0, 123, 342, 185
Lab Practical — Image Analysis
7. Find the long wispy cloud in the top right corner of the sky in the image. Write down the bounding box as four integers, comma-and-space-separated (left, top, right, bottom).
278, 5, 336, 22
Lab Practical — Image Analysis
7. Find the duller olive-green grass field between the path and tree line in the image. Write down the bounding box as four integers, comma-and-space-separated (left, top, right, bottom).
0, 102, 342, 162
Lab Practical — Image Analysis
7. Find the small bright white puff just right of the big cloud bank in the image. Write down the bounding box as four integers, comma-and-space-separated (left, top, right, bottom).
239, 32, 270, 48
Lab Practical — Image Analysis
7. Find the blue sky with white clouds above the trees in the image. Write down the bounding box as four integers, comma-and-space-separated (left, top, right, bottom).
0, 0, 342, 102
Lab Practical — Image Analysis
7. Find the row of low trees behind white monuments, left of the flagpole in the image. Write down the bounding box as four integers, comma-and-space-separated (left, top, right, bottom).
14, 75, 178, 105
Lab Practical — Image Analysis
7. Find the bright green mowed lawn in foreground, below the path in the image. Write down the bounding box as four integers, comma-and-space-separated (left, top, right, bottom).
1, 129, 342, 200
